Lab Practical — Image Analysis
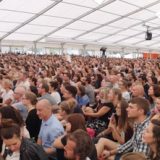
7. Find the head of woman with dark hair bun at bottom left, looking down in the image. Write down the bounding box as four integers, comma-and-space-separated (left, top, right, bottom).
1, 120, 22, 152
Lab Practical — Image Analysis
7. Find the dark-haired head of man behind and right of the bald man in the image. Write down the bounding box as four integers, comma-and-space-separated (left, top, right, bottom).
63, 85, 77, 99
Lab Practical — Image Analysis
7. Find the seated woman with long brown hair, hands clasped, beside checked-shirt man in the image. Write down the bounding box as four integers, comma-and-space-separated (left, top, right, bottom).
96, 100, 133, 156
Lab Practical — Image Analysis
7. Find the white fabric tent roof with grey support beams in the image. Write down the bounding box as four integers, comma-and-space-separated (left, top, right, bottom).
0, 0, 160, 49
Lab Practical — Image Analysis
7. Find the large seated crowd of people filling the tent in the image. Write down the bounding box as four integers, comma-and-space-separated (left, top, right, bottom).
0, 54, 160, 160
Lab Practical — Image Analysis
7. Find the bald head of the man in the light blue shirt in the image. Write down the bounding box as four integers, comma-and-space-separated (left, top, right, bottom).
36, 99, 53, 121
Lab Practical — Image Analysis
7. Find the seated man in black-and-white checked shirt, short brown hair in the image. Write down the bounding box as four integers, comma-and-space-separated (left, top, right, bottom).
102, 97, 150, 159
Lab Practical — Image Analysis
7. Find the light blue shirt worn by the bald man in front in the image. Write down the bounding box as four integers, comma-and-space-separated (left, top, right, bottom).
38, 115, 64, 148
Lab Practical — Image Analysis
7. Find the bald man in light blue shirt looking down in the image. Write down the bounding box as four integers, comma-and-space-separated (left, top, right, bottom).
36, 99, 64, 156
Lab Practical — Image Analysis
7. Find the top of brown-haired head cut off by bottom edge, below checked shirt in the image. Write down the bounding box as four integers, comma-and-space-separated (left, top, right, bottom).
121, 152, 147, 160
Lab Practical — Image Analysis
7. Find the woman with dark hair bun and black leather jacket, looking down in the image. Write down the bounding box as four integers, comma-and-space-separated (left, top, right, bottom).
1, 121, 48, 160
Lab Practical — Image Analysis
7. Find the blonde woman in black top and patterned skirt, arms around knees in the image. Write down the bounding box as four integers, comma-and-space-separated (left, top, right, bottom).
83, 88, 115, 134
